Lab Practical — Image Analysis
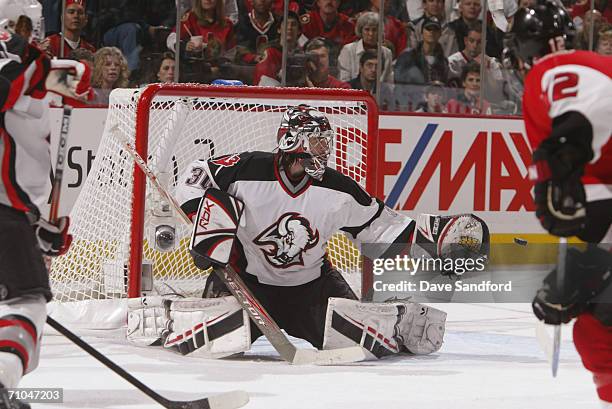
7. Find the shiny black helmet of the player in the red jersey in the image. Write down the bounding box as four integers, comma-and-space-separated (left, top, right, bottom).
503, 0, 575, 70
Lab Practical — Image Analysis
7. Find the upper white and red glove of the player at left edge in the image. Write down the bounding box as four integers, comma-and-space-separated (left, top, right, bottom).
45, 60, 93, 101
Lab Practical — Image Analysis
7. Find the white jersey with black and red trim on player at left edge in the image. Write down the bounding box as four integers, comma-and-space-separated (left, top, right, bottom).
0, 31, 51, 213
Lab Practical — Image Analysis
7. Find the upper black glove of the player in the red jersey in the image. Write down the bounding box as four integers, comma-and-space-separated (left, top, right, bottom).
530, 138, 586, 237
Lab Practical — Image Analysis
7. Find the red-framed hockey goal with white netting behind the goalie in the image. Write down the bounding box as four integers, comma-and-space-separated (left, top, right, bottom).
51, 84, 378, 326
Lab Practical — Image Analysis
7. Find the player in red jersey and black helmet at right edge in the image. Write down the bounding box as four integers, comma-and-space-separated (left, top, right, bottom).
505, 2, 612, 407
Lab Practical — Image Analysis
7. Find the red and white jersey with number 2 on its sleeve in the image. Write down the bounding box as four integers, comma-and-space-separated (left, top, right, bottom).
523, 51, 612, 196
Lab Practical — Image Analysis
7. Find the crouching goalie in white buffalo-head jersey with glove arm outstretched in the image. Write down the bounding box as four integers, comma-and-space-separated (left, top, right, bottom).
128, 105, 489, 359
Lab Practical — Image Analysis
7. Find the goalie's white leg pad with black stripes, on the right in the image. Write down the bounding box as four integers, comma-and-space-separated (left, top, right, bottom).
323, 298, 446, 359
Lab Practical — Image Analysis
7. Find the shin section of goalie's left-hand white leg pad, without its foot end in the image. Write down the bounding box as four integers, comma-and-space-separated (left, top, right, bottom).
164, 296, 251, 358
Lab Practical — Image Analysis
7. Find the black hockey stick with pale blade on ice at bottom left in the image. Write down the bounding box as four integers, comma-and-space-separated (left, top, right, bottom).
47, 317, 249, 409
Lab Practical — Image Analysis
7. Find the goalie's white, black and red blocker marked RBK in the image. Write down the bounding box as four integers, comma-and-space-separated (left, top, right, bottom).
189, 188, 244, 269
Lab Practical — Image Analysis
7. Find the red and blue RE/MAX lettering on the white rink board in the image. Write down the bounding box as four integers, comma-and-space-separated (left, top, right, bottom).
376, 123, 535, 211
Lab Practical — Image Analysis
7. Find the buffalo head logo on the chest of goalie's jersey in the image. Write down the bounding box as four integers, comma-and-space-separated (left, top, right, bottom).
253, 212, 319, 268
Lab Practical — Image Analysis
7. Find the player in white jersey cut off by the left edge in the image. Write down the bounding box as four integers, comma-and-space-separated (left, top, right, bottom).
0, 0, 90, 409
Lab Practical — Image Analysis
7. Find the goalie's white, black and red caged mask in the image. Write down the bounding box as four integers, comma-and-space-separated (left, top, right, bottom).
277, 105, 334, 180
